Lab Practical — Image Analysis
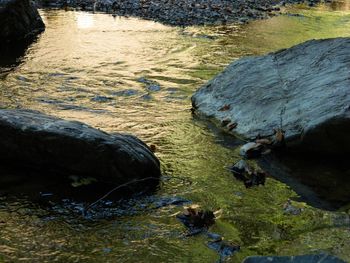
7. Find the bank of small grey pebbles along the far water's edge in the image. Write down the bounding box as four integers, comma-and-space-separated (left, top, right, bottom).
41, 0, 319, 26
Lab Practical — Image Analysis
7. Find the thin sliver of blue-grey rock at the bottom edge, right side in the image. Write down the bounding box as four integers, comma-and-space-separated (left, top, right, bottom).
243, 254, 345, 263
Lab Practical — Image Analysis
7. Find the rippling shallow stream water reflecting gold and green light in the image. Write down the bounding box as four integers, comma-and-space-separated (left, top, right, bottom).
0, 1, 350, 262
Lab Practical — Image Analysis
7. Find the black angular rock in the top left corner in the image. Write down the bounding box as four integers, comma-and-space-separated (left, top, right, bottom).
0, 0, 45, 45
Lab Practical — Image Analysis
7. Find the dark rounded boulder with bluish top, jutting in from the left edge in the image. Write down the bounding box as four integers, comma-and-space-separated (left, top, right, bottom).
0, 110, 160, 189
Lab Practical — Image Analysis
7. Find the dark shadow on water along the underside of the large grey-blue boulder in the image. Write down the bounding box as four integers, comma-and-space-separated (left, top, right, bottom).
194, 116, 350, 211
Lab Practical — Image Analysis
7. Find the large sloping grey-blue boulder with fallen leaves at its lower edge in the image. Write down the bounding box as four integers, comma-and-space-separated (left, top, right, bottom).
192, 38, 350, 154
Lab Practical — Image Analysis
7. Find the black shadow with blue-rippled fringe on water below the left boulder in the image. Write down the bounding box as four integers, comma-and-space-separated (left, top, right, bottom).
0, 162, 171, 220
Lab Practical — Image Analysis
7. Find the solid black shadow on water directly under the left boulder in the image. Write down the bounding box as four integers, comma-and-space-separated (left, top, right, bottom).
0, 162, 159, 203
